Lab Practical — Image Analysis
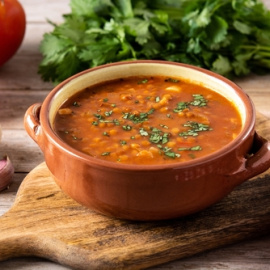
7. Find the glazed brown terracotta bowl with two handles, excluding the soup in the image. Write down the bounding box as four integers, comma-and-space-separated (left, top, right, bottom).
25, 61, 270, 220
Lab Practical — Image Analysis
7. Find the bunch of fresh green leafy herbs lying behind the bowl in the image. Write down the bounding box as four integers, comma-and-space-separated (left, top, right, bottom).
39, 0, 270, 83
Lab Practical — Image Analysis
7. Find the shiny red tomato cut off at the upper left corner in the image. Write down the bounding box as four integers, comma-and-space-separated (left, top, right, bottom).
0, 0, 26, 66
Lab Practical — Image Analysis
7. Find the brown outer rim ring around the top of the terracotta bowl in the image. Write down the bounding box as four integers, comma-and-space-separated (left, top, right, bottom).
39, 60, 255, 171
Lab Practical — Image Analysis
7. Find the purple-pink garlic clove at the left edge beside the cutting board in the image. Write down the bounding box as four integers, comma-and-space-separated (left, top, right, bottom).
0, 156, 14, 191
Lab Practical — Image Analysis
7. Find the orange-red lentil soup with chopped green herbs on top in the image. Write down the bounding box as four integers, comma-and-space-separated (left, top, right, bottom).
54, 76, 242, 164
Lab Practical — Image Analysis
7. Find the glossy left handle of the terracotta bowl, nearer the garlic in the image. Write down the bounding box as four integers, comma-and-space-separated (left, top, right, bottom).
24, 103, 43, 149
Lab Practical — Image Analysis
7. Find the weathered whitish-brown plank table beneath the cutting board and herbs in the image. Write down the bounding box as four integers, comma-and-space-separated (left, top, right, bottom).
0, 0, 270, 270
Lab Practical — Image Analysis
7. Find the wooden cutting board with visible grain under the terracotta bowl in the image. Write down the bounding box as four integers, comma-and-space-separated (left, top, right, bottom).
0, 115, 270, 269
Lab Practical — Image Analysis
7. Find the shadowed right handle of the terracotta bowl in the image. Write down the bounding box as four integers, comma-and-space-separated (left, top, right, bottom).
230, 132, 270, 184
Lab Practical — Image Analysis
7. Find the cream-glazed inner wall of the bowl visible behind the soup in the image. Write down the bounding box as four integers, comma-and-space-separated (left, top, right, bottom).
49, 62, 247, 125
